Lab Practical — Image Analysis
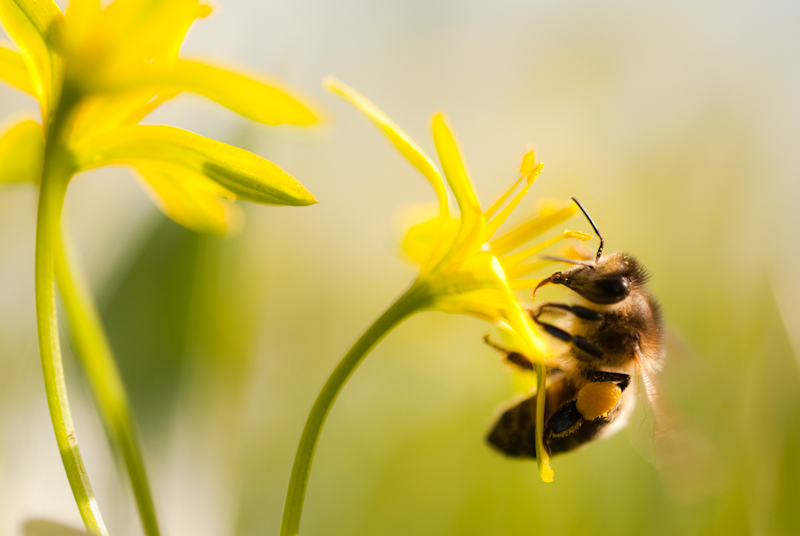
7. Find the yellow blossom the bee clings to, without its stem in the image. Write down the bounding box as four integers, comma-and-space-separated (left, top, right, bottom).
326, 79, 590, 481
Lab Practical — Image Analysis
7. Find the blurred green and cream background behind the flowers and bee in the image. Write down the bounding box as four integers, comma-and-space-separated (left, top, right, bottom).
0, 0, 800, 536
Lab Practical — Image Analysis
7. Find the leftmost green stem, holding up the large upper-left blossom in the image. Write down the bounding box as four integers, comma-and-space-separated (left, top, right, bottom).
35, 95, 108, 536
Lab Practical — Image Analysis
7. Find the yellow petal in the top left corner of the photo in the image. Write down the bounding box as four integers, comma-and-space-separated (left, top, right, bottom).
0, 0, 64, 117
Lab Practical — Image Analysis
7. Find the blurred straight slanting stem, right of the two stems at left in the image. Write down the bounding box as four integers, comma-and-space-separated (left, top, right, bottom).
55, 231, 160, 536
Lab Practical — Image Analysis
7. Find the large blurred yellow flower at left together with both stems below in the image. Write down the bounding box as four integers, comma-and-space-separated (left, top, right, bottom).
0, 0, 317, 536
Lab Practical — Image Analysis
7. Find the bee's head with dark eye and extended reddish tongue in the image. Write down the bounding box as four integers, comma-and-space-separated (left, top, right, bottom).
536, 251, 646, 305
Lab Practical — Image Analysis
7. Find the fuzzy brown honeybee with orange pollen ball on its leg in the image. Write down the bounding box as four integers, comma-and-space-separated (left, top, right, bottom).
486, 197, 664, 458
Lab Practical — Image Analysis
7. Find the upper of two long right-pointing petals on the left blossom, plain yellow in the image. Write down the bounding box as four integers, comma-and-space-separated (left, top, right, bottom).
128, 60, 317, 125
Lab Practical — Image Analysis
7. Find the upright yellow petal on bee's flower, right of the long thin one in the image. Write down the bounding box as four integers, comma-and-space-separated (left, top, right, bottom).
433, 114, 486, 266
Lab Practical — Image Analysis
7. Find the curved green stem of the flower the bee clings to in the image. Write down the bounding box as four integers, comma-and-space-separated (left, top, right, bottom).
281, 285, 427, 536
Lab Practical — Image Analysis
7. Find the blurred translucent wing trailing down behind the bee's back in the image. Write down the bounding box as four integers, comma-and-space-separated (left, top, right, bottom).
628, 356, 728, 502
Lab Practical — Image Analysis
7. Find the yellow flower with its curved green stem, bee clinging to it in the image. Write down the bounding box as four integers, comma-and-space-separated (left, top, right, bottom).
281, 78, 591, 536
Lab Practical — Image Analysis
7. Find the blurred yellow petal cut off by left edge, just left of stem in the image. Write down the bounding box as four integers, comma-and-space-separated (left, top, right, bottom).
0, 119, 44, 183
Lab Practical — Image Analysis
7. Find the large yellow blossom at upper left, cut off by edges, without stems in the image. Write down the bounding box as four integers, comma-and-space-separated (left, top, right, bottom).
0, 0, 317, 234
